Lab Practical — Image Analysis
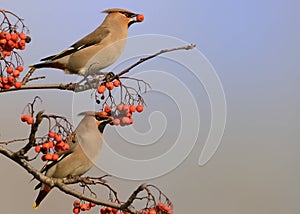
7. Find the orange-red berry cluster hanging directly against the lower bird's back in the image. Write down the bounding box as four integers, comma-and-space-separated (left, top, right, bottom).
35, 131, 69, 161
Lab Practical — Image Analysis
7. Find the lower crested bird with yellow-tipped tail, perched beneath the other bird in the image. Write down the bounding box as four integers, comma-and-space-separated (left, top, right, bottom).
33, 111, 111, 209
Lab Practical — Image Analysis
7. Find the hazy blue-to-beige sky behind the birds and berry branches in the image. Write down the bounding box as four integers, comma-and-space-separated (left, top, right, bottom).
0, 0, 300, 214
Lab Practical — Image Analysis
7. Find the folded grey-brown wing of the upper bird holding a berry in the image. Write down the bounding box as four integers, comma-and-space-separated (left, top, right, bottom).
41, 26, 110, 61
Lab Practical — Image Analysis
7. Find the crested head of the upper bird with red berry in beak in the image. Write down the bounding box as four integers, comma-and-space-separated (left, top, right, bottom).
102, 8, 144, 27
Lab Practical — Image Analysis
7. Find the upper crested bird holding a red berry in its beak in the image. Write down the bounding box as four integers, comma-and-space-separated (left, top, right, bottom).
29, 8, 144, 75
